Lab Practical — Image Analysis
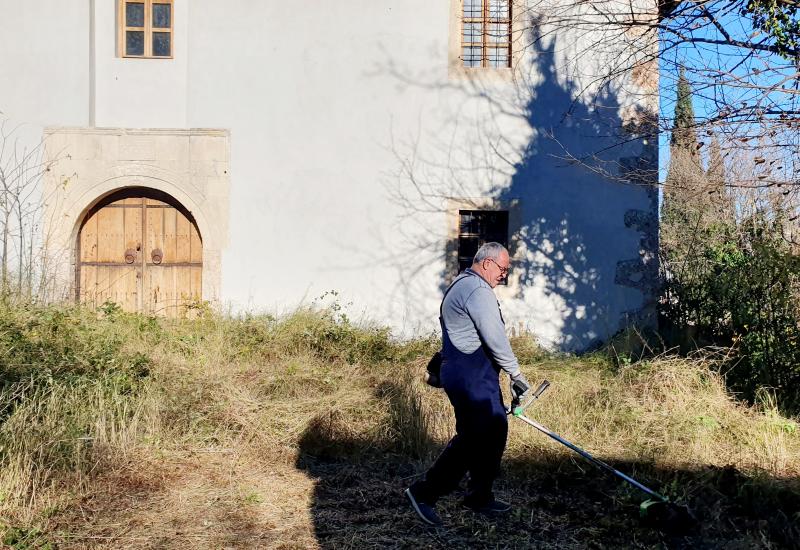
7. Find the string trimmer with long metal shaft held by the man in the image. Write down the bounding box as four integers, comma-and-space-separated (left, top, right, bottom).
508, 380, 696, 531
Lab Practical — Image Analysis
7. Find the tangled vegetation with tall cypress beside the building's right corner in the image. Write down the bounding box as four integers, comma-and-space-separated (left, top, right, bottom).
661, 64, 800, 414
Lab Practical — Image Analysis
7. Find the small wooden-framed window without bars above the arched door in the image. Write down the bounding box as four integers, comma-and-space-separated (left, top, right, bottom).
119, 0, 173, 58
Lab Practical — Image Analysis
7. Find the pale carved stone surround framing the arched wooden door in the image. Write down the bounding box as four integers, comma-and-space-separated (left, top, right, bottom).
43, 128, 230, 303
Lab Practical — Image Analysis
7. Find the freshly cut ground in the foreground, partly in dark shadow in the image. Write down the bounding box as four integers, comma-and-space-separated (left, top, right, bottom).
49, 448, 785, 549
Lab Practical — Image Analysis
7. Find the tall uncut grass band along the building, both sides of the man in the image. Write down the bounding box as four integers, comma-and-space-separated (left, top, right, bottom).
0, 307, 800, 548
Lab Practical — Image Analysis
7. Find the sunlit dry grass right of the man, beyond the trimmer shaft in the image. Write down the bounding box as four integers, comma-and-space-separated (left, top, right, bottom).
504, 358, 800, 477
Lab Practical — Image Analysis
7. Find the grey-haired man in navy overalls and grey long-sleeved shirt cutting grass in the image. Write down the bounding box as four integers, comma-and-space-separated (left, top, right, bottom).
405, 243, 530, 525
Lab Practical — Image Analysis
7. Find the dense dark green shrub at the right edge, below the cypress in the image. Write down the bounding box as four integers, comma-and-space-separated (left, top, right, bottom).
662, 216, 800, 413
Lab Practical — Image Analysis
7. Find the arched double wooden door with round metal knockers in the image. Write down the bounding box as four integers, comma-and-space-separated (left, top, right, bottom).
76, 188, 203, 317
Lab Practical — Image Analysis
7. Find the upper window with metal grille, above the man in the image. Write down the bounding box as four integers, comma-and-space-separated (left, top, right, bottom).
461, 0, 511, 68
